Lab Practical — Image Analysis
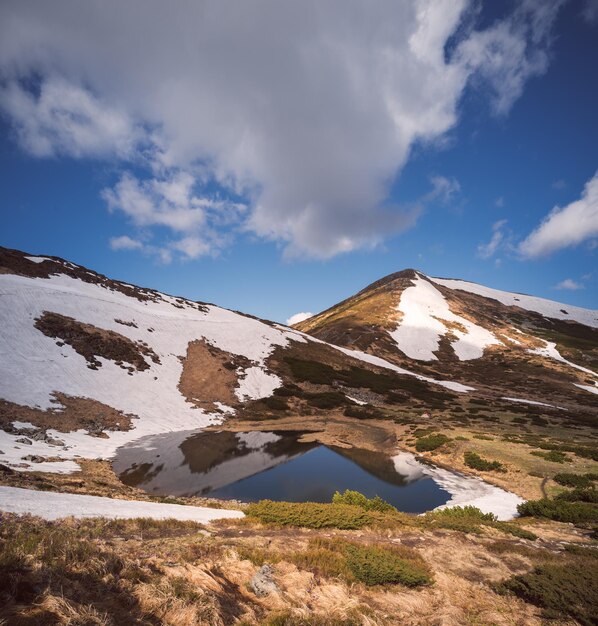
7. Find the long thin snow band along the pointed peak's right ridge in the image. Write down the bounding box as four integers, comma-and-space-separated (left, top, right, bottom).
428, 277, 598, 328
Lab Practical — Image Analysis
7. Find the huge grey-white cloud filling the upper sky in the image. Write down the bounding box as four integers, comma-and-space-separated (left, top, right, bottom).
0, 0, 561, 258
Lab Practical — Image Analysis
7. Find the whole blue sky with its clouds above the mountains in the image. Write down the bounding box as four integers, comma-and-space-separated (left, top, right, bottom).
0, 0, 598, 321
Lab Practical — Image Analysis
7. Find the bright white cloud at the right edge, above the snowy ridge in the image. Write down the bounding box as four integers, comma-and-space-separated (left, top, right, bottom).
519, 172, 598, 258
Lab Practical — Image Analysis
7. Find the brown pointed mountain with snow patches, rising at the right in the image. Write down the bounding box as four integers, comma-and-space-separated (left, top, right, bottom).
295, 270, 598, 414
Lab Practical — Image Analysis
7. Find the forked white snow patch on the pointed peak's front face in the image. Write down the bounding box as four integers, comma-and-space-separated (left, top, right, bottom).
389, 274, 502, 361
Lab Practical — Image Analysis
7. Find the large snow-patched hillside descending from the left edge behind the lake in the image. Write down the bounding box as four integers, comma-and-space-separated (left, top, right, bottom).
0, 249, 478, 472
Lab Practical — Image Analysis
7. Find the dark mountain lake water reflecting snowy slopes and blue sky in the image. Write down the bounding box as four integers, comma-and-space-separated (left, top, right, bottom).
113, 431, 450, 513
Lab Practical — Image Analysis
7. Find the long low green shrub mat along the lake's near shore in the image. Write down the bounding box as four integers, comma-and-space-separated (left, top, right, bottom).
246, 500, 372, 530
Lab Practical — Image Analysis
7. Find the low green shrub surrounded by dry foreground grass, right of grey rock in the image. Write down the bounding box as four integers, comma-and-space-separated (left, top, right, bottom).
345, 544, 432, 587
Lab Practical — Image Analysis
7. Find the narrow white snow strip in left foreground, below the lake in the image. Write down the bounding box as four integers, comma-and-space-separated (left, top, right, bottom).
0, 486, 245, 524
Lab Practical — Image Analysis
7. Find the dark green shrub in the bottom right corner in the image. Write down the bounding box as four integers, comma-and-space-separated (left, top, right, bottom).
496, 558, 598, 626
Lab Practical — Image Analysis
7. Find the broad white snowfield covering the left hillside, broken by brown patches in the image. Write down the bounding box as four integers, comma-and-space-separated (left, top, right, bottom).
0, 274, 307, 472
